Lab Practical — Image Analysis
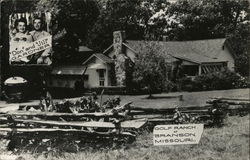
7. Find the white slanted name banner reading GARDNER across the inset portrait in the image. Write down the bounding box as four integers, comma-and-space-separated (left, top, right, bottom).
10, 36, 52, 62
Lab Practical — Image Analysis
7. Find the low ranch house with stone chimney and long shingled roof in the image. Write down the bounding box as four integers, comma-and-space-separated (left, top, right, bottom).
49, 31, 234, 89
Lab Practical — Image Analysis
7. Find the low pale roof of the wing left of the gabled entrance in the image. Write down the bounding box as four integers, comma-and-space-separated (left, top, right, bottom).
51, 66, 86, 75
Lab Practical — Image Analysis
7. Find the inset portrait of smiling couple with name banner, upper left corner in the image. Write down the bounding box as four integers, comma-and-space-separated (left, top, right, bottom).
9, 11, 53, 65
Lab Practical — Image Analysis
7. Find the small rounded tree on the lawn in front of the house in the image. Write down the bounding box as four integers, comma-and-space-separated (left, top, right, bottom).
133, 42, 167, 98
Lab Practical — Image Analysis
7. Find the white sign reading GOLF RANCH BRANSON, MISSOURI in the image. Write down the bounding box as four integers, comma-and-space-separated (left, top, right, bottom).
153, 124, 204, 146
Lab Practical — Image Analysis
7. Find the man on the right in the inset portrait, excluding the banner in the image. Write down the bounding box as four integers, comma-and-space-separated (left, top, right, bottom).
30, 18, 52, 65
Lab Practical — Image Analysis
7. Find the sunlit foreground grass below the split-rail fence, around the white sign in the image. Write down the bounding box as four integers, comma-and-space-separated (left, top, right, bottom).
2, 115, 250, 160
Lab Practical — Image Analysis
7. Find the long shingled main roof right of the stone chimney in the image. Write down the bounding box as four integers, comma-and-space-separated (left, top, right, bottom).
124, 38, 230, 63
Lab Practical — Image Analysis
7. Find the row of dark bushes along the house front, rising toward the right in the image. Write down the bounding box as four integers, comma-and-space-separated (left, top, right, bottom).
126, 70, 250, 94
